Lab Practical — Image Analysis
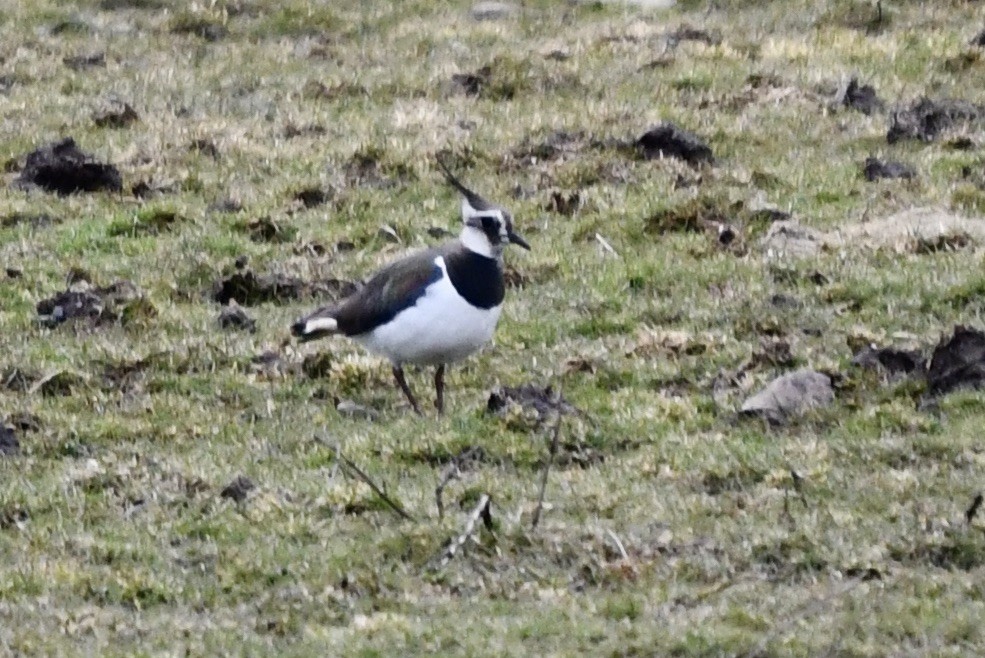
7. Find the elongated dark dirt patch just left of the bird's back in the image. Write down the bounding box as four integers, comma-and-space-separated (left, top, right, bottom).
212, 269, 357, 306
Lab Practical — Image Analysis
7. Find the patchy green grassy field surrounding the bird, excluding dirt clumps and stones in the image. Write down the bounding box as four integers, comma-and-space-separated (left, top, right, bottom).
0, 0, 985, 656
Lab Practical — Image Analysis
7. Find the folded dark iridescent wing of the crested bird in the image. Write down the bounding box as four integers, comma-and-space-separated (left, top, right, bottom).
333, 249, 442, 336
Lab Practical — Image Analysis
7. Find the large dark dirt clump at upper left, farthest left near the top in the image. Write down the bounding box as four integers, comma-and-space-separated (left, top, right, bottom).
16, 137, 123, 196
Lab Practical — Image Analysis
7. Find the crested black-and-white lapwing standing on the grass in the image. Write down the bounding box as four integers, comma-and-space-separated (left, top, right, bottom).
291, 161, 530, 415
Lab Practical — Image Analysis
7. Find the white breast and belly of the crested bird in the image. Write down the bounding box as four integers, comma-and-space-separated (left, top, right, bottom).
353, 256, 503, 365
